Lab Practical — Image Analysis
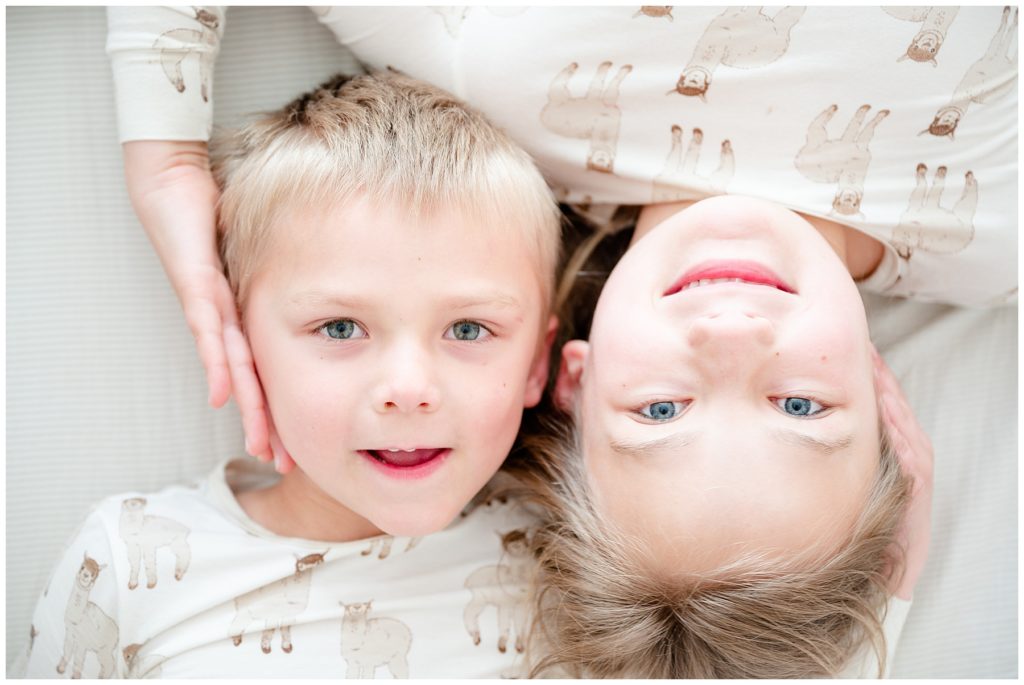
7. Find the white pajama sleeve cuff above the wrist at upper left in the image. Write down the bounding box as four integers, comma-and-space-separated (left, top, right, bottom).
106, 6, 225, 142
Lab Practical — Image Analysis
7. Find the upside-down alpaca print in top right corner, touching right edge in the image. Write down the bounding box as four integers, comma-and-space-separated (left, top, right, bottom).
921, 7, 1018, 139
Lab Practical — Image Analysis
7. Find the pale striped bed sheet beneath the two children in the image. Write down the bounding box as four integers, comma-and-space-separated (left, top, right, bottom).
6, 7, 1018, 678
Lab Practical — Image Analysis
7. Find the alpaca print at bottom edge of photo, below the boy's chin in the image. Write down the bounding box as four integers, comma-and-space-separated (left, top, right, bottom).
338, 600, 413, 678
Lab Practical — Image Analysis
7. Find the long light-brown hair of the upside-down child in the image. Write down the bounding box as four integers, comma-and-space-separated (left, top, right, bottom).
503, 416, 909, 678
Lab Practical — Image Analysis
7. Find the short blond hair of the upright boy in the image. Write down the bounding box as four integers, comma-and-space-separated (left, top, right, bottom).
211, 72, 560, 308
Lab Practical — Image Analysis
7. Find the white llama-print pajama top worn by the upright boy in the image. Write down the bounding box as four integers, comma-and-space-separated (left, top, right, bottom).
25, 460, 531, 679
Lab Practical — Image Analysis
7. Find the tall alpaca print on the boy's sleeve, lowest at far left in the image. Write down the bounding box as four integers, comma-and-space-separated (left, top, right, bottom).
57, 553, 118, 678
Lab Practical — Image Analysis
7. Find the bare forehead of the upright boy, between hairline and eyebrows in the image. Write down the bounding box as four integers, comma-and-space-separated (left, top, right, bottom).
245, 194, 551, 309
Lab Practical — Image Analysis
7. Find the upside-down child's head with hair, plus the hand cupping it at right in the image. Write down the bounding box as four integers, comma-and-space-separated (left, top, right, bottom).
512, 196, 931, 678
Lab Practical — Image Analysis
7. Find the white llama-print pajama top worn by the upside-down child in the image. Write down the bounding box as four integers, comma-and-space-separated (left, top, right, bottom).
108, 5, 1019, 305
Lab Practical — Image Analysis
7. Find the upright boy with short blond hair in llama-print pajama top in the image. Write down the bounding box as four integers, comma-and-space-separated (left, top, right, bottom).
27, 74, 560, 678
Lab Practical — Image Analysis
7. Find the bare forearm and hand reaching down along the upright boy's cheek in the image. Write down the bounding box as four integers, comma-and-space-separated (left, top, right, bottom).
124, 140, 294, 473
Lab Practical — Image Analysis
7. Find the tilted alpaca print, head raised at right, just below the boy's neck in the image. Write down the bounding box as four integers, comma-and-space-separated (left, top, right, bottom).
228, 552, 327, 654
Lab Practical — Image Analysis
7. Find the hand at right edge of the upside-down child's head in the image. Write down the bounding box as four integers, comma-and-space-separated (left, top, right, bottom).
871, 348, 935, 600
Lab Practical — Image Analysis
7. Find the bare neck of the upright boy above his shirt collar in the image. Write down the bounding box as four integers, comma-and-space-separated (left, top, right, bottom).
237, 467, 382, 543
